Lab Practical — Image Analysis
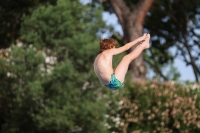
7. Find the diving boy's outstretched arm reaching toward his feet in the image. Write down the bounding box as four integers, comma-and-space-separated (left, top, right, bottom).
111, 33, 147, 55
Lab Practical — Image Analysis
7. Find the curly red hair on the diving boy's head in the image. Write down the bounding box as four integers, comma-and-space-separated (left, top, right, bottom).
99, 39, 117, 53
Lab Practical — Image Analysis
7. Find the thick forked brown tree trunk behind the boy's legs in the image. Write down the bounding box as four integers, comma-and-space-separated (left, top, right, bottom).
109, 0, 154, 82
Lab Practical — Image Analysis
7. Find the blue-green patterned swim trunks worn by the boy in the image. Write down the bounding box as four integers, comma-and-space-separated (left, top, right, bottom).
105, 73, 123, 90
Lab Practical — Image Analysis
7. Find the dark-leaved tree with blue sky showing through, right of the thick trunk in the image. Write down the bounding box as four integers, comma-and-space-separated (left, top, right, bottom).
144, 0, 200, 82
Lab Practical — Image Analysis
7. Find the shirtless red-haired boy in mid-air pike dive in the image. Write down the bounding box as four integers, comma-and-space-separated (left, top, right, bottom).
94, 34, 150, 90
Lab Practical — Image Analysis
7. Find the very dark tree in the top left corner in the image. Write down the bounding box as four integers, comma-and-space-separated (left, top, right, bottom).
0, 0, 57, 48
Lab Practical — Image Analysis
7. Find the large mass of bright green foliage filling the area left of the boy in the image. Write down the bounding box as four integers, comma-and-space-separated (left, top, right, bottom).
0, 0, 109, 133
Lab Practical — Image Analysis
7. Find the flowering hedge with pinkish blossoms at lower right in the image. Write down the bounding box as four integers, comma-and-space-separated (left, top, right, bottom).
106, 82, 200, 133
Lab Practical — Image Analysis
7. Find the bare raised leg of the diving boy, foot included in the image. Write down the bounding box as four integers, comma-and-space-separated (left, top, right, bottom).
115, 34, 150, 83
